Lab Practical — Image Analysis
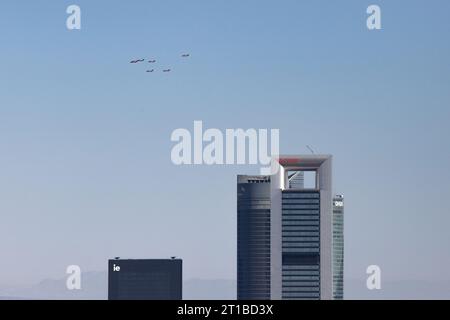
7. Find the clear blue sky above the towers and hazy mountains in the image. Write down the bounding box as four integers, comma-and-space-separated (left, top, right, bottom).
0, 0, 450, 284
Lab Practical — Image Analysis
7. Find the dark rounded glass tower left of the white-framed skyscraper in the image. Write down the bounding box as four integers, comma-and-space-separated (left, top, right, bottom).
237, 176, 270, 300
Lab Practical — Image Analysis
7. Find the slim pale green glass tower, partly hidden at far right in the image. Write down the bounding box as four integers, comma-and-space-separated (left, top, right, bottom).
333, 195, 344, 300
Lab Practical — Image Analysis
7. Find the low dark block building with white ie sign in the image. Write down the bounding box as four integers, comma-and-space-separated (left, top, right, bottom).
108, 259, 182, 300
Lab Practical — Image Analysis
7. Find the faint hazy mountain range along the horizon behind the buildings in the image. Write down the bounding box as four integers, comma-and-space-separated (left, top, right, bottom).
0, 271, 450, 300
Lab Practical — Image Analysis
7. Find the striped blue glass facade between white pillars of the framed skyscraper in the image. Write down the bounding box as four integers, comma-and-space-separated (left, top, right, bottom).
282, 190, 320, 300
